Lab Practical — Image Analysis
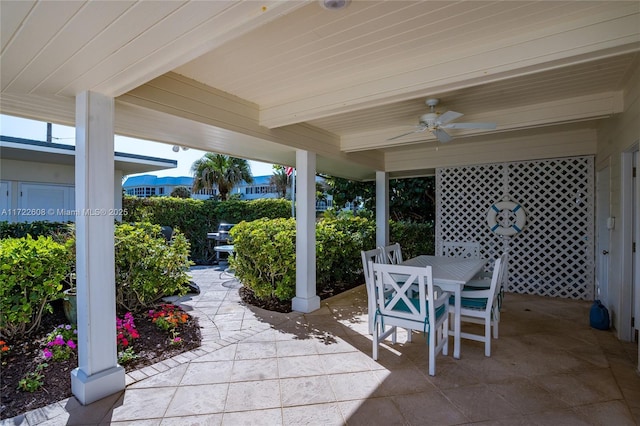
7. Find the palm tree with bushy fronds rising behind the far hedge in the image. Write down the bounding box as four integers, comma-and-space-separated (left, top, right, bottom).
191, 152, 253, 201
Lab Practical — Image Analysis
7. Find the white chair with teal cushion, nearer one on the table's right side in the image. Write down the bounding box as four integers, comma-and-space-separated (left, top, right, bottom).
449, 253, 507, 356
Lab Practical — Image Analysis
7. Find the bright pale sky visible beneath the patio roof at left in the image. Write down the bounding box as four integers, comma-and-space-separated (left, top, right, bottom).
0, 115, 273, 177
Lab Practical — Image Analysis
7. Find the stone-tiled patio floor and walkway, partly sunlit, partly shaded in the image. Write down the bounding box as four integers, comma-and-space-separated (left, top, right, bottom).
2, 267, 640, 426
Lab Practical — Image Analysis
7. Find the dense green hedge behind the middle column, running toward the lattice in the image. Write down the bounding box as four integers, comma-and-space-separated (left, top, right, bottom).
230, 217, 433, 300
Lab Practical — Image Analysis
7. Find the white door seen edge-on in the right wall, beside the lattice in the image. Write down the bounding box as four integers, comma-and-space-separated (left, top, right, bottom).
596, 167, 613, 307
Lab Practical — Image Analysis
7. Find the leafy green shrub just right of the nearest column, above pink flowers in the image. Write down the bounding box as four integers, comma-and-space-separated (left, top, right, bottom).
115, 223, 192, 311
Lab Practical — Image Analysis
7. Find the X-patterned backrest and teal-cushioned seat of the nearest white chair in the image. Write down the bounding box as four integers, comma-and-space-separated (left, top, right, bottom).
369, 262, 449, 328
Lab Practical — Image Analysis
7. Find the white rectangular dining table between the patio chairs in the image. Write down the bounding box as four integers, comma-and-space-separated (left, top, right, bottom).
402, 255, 487, 358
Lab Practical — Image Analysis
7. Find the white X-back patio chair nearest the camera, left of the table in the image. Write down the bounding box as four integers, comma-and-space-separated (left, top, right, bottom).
369, 262, 451, 376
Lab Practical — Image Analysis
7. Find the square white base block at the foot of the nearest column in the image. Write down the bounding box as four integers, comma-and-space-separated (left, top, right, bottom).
71, 365, 125, 405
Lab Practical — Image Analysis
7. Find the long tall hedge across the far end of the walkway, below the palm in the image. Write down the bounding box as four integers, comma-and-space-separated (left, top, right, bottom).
122, 196, 291, 263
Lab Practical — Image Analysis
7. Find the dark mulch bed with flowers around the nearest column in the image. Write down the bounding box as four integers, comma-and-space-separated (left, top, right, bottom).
0, 301, 201, 419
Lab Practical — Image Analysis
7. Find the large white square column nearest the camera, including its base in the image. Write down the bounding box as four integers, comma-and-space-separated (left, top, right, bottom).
71, 92, 125, 405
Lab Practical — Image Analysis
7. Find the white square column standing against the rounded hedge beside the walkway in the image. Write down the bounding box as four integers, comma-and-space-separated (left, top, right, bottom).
291, 151, 320, 312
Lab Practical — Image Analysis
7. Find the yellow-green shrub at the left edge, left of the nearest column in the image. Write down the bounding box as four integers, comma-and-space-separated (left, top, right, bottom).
0, 235, 73, 338
